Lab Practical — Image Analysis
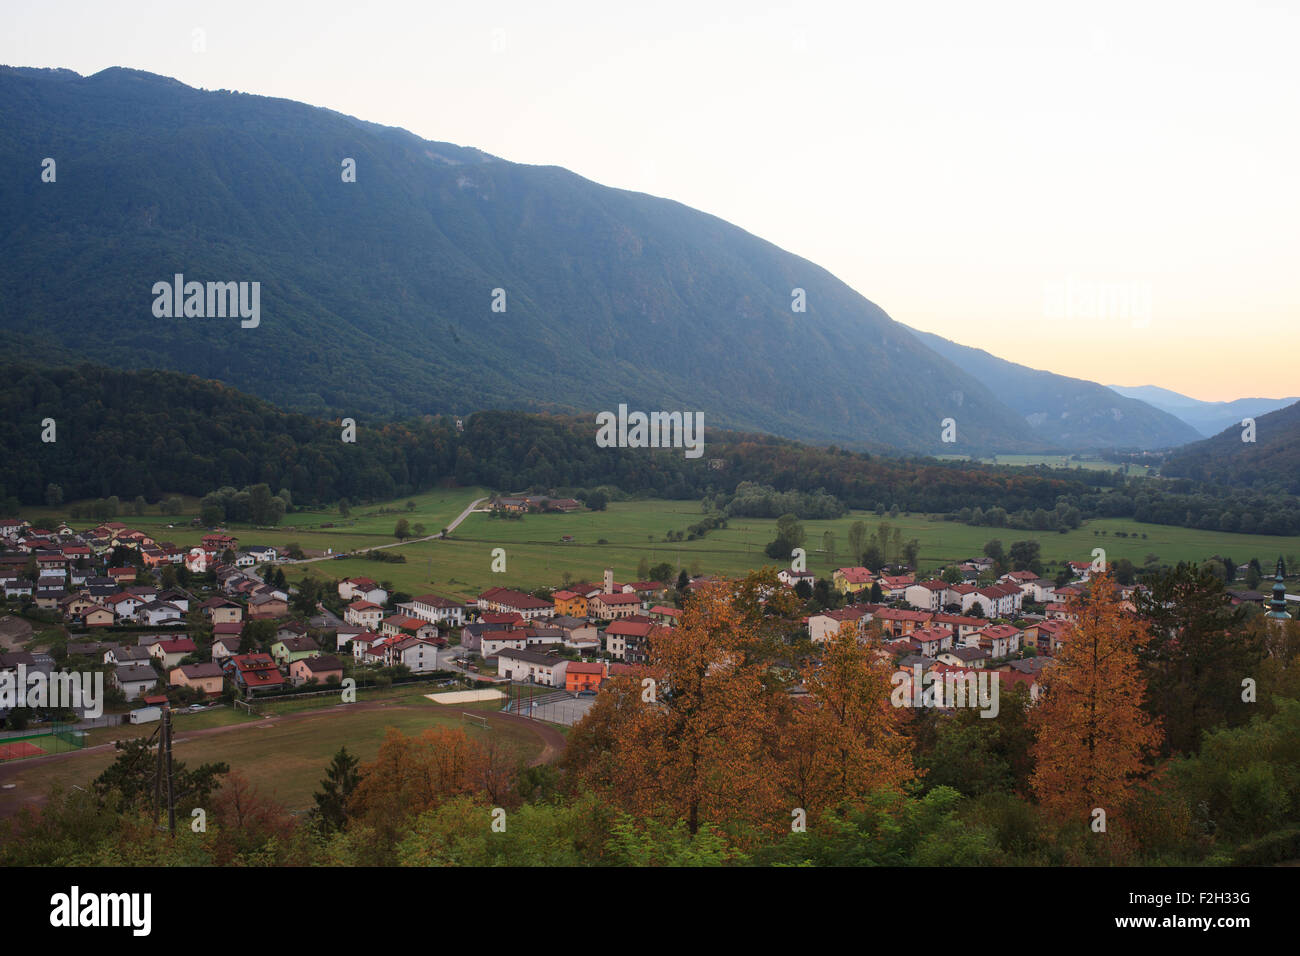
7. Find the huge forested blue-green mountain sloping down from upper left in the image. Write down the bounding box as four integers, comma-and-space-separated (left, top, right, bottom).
0, 68, 1045, 454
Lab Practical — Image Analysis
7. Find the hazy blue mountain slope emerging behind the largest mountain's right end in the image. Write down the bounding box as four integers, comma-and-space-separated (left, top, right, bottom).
915, 332, 1199, 449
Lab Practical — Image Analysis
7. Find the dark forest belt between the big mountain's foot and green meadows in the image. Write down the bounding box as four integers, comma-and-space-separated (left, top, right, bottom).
0, 364, 1300, 535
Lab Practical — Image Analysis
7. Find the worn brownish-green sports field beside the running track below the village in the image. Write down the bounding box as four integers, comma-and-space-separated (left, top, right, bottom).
0, 696, 541, 816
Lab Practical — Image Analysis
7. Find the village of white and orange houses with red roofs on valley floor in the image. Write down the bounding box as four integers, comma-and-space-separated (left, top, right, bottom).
10, 512, 1284, 719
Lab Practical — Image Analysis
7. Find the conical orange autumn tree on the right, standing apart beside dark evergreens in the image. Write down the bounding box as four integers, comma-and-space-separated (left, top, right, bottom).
1031, 574, 1161, 823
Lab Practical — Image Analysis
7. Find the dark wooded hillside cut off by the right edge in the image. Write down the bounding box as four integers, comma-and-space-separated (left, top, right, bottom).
1160, 402, 1300, 496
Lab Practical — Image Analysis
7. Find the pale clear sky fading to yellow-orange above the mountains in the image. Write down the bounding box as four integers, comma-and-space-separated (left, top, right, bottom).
0, 0, 1300, 401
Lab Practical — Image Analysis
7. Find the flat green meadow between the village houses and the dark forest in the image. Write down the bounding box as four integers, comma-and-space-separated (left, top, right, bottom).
286, 501, 1300, 597
